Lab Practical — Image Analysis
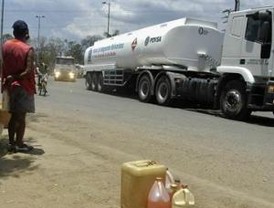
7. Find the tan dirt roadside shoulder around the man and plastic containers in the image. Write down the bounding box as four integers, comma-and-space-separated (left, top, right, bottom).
0, 106, 273, 208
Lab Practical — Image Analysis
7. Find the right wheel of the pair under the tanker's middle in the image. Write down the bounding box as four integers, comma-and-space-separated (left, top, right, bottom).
155, 76, 171, 105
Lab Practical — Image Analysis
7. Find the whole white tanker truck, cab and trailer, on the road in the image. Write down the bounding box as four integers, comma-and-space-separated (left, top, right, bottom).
84, 7, 274, 120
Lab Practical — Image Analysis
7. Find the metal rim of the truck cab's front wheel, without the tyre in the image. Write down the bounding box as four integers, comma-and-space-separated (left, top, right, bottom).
224, 90, 243, 114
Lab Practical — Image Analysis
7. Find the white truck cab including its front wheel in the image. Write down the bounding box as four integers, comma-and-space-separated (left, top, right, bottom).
217, 7, 274, 117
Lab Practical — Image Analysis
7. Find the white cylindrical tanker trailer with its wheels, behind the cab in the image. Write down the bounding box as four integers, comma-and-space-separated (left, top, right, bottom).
84, 18, 223, 102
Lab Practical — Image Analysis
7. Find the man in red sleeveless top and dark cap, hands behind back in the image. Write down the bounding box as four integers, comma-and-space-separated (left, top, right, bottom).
2, 20, 36, 152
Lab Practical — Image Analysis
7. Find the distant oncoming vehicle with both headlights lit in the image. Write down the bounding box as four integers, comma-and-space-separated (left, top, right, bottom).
53, 56, 77, 82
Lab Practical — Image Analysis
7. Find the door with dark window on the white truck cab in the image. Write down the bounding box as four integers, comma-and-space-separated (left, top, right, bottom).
240, 12, 273, 77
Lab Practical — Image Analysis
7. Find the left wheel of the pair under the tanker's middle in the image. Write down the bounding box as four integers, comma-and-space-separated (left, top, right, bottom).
138, 75, 152, 102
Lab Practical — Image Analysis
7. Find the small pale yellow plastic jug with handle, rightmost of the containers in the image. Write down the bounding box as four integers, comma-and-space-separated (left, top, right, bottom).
172, 188, 195, 208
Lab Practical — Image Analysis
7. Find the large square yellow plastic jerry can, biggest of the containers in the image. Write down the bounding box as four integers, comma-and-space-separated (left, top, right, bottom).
121, 160, 167, 208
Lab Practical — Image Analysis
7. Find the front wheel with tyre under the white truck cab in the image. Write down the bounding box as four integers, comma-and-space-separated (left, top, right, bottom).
220, 80, 251, 120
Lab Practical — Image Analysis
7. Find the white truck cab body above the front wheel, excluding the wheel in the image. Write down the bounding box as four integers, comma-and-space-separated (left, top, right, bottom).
219, 8, 274, 78
